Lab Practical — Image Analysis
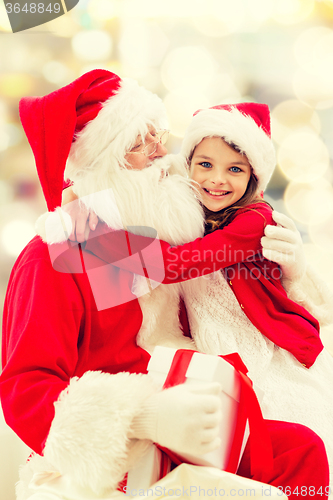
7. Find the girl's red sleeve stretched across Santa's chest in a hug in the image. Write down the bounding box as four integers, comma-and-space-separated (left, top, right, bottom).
85, 204, 275, 283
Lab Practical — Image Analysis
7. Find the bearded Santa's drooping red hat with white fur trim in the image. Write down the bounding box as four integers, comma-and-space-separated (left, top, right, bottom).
19, 69, 167, 211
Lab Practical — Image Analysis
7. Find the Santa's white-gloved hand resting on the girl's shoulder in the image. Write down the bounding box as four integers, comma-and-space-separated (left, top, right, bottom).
261, 211, 307, 281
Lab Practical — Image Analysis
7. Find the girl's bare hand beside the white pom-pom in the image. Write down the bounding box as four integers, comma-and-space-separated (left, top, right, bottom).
61, 187, 98, 243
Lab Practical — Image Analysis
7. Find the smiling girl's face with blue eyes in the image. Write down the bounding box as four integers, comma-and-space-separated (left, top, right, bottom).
190, 137, 251, 212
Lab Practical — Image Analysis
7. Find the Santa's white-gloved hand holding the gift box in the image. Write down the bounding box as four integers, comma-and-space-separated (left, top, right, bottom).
131, 383, 222, 455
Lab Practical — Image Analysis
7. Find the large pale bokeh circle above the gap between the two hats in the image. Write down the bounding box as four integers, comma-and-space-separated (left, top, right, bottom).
161, 46, 217, 90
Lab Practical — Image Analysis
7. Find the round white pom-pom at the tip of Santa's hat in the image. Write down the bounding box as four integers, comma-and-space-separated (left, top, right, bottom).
35, 207, 73, 245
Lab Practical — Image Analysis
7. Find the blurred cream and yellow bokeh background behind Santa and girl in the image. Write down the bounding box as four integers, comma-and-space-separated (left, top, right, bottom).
0, 0, 333, 500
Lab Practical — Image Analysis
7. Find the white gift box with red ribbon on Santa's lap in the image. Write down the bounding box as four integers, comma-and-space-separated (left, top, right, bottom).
127, 346, 262, 490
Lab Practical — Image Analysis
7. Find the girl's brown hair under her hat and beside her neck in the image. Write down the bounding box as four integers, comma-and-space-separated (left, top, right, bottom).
188, 137, 272, 234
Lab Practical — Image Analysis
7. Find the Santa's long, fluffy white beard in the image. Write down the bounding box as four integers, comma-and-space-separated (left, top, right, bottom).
74, 155, 204, 245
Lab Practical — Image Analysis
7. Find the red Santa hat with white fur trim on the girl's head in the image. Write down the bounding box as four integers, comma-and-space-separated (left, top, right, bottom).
181, 102, 276, 191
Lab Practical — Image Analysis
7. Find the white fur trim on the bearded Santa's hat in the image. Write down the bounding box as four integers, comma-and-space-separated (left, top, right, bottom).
65, 78, 168, 195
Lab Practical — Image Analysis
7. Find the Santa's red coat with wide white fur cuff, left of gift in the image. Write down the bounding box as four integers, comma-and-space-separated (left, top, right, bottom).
1, 237, 153, 489
